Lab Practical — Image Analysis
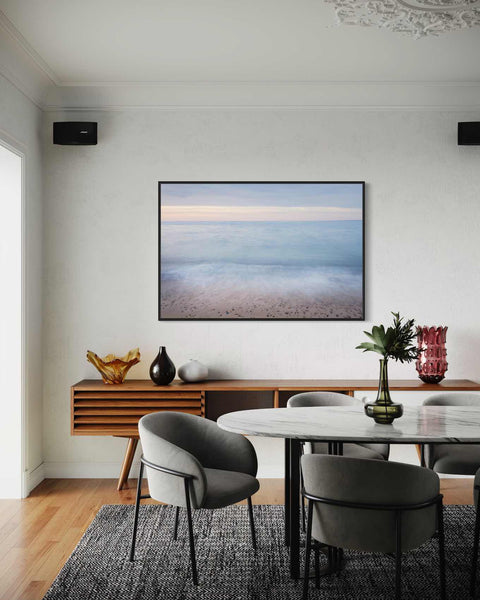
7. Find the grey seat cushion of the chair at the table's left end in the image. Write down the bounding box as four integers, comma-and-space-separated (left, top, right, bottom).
202, 469, 260, 508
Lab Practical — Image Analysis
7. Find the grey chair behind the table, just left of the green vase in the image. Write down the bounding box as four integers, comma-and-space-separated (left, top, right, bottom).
287, 392, 390, 460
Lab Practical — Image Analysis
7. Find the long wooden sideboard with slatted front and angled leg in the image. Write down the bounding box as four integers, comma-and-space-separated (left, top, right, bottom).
71, 379, 480, 490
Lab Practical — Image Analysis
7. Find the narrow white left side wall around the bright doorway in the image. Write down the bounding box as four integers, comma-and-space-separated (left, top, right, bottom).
0, 76, 43, 491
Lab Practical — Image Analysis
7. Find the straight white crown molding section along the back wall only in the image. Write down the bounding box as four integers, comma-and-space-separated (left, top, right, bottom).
44, 81, 480, 111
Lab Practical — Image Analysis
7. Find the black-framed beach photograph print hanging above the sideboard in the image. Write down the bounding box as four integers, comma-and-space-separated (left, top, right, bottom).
159, 182, 365, 320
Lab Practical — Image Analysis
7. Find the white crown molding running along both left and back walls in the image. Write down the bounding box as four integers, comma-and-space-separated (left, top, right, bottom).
0, 11, 480, 111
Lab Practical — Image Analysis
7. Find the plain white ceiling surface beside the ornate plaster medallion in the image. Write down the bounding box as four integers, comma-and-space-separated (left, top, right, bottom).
0, 0, 480, 86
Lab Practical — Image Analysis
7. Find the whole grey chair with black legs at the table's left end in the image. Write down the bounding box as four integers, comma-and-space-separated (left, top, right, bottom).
130, 412, 260, 584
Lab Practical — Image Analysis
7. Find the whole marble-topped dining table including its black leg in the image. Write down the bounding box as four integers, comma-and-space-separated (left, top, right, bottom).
217, 402, 480, 579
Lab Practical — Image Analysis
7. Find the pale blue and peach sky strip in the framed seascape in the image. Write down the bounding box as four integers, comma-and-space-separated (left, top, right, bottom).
161, 183, 363, 222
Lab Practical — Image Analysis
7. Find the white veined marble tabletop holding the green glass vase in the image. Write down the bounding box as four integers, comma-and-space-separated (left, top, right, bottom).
217, 405, 480, 444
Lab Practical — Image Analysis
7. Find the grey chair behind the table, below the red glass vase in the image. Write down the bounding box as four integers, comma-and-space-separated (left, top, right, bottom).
422, 392, 480, 475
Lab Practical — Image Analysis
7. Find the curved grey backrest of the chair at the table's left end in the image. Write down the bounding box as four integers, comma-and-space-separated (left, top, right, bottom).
138, 412, 257, 508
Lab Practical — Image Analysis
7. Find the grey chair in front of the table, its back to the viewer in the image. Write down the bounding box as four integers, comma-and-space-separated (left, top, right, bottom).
301, 454, 446, 600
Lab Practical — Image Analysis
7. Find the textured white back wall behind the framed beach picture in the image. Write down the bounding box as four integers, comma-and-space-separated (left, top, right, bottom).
43, 109, 480, 476
